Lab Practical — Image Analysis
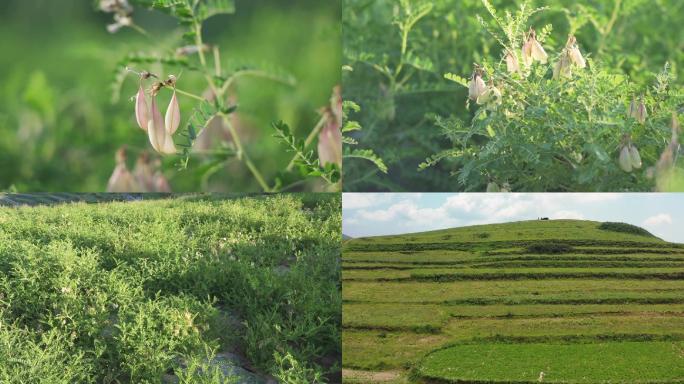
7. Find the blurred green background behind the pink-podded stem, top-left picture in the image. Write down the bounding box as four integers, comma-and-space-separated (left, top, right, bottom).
0, 0, 341, 192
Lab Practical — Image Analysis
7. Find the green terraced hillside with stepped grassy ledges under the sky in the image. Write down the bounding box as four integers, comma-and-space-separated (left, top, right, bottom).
342, 220, 684, 383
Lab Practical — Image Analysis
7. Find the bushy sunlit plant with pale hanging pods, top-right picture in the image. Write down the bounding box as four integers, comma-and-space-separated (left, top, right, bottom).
420, 0, 682, 191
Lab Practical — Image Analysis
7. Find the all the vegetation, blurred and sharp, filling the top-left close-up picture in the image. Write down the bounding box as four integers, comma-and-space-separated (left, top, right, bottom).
0, 0, 342, 192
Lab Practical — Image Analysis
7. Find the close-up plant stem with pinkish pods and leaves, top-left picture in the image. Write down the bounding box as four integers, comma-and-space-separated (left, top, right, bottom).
96, 0, 342, 192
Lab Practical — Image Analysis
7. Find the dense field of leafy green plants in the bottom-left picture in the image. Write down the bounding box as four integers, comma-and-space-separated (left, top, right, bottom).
0, 194, 341, 384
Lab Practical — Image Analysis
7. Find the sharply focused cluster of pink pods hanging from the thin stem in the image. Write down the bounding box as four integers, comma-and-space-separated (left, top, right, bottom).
135, 72, 180, 155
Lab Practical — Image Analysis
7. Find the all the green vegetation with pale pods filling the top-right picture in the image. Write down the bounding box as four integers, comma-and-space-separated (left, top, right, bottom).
342, 0, 684, 192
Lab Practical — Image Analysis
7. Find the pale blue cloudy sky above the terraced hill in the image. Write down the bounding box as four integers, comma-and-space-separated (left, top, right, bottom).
342, 193, 684, 243
